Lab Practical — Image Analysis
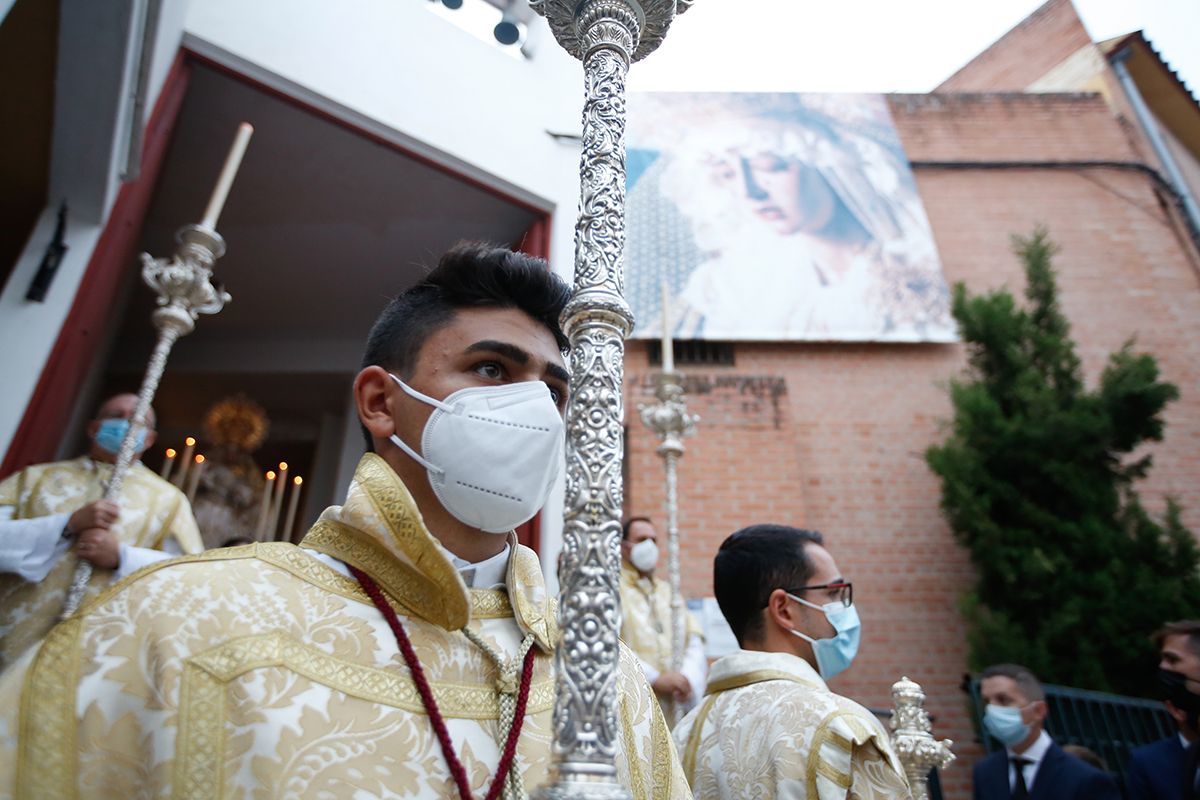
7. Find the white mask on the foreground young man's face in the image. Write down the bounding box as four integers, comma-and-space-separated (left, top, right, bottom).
389, 373, 563, 534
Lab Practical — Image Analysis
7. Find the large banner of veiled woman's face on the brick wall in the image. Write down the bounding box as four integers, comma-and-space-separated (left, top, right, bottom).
625, 94, 958, 342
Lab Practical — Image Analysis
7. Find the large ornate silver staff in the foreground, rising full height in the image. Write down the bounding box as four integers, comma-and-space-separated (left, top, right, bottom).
529, 0, 686, 799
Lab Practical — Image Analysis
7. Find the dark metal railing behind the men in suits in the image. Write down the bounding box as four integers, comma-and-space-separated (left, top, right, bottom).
964, 678, 1176, 786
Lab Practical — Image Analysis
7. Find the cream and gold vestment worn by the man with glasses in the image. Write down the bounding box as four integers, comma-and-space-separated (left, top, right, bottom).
674, 650, 911, 800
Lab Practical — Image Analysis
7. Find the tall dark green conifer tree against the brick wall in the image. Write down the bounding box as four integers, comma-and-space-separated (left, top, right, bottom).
925, 228, 1200, 694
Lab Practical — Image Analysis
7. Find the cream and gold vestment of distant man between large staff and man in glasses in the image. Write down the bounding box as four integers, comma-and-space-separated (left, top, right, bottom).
620, 559, 708, 715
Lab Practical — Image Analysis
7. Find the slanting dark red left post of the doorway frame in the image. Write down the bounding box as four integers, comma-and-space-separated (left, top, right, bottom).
0, 52, 192, 479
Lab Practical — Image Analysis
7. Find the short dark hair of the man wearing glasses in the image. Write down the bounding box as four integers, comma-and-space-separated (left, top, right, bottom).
713, 525, 824, 648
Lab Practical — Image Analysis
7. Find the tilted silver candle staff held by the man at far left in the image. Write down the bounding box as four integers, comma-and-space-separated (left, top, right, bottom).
59, 225, 229, 619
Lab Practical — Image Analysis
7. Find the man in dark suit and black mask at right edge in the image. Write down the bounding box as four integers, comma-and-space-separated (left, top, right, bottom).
1126, 620, 1200, 800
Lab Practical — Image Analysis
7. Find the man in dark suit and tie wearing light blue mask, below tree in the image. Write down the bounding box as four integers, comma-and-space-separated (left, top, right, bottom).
974, 664, 1121, 800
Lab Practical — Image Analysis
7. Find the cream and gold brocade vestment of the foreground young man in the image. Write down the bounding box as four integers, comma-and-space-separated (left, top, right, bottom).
0, 453, 690, 800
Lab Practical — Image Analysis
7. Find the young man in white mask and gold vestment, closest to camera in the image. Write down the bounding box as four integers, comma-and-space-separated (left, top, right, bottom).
0, 245, 688, 800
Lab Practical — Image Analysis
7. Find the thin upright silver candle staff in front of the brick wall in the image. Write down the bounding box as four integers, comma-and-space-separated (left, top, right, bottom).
638, 372, 700, 723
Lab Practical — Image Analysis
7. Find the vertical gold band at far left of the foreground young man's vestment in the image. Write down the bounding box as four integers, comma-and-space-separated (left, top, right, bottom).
16, 616, 83, 800
